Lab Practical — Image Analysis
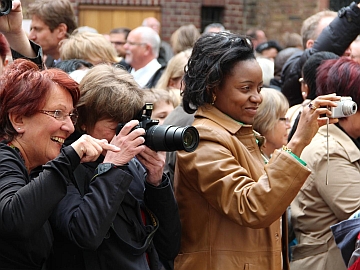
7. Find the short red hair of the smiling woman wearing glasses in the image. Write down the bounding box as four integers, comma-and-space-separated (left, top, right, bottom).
0, 59, 80, 140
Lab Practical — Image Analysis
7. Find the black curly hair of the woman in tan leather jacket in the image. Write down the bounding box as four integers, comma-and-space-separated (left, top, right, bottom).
183, 32, 255, 113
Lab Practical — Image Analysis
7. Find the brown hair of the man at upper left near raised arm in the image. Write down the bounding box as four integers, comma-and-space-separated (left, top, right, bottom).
27, 0, 77, 35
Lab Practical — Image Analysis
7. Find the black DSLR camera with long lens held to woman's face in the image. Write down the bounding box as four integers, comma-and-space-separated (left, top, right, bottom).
116, 103, 199, 152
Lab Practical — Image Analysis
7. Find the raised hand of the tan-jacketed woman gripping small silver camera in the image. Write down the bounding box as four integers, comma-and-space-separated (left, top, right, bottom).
287, 94, 341, 156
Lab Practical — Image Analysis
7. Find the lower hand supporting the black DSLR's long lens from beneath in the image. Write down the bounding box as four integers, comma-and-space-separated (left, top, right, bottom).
136, 147, 166, 186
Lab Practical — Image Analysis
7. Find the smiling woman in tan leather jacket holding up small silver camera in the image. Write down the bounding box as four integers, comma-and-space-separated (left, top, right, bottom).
174, 32, 339, 270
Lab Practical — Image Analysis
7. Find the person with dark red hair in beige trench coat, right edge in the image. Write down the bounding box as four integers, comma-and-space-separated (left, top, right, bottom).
291, 57, 360, 270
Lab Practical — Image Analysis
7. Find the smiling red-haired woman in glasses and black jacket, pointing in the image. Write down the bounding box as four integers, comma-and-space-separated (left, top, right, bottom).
0, 59, 119, 269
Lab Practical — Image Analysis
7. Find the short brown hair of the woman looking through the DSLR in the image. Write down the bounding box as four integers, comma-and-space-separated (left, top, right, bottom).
77, 64, 144, 131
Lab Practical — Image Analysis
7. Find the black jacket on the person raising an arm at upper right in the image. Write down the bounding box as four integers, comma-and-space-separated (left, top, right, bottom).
281, 2, 360, 107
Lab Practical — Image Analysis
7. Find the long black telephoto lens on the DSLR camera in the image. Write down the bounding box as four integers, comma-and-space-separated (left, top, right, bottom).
145, 125, 199, 152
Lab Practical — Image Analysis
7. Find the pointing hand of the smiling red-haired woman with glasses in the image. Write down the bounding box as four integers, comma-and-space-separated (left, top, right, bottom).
71, 134, 120, 163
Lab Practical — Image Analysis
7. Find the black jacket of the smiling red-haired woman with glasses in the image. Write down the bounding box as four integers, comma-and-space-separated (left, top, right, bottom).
0, 143, 80, 270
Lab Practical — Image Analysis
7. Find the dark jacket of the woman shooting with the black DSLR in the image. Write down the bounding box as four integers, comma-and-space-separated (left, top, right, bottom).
51, 132, 181, 270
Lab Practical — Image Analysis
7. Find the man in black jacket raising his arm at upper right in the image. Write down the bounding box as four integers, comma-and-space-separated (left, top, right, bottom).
281, 2, 360, 107
